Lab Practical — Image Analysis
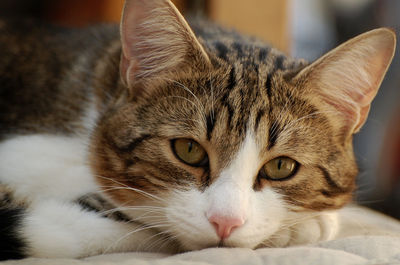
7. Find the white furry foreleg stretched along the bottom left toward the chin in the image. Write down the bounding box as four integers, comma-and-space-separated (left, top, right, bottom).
20, 200, 177, 258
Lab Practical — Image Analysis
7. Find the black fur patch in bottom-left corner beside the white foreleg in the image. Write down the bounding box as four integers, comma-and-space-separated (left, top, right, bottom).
0, 207, 26, 260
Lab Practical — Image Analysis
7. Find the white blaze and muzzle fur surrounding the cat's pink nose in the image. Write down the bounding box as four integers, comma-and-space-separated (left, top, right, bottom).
166, 132, 287, 250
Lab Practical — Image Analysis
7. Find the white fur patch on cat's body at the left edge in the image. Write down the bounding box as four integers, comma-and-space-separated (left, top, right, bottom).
0, 135, 97, 200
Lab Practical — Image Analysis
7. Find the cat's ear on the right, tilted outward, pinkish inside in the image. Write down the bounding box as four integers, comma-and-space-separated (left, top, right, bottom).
296, 28, 396, 134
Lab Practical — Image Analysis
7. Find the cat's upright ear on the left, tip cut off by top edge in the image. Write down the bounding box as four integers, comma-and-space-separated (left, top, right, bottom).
120, 0, 209, 93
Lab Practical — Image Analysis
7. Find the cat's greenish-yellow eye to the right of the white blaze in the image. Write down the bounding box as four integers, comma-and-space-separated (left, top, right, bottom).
260, 156, 299, 180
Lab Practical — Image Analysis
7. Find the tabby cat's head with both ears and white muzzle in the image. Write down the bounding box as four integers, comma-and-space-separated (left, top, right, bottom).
91, 0, 395, 249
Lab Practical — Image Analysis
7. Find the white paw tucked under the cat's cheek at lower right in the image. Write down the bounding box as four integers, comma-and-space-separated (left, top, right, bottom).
266, 209, 339, 247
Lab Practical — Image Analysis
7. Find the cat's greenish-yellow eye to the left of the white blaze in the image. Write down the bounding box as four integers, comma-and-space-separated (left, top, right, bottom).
172, 138, 208, 167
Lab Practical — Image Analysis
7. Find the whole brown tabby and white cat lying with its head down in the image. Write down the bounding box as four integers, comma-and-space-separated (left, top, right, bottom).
0, 0, 395, 260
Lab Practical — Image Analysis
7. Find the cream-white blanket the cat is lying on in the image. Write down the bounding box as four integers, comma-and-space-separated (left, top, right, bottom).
4, 207, 400, 265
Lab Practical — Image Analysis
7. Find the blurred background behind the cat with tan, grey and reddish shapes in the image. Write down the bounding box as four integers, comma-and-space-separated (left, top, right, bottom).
0, 0, 400, 219
